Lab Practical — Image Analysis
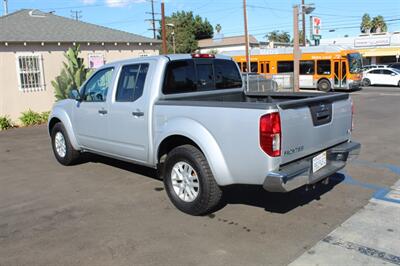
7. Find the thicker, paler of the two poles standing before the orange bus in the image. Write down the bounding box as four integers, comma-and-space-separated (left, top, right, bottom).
293, 5, 300, 92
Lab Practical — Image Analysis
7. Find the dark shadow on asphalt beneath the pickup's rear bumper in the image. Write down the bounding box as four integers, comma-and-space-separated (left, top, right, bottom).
218, 173, 345, 213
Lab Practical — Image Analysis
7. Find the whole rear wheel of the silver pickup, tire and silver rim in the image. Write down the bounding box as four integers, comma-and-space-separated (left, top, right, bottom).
164, 145, 222, 215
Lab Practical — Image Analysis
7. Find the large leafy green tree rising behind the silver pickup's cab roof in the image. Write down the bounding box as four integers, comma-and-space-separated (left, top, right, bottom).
159, 11, 214, 53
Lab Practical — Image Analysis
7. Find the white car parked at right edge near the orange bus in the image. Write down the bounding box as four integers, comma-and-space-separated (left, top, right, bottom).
362, 68, 400, 87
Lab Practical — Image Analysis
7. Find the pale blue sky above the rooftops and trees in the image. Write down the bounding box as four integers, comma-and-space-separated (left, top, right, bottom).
0, 0, 400, 41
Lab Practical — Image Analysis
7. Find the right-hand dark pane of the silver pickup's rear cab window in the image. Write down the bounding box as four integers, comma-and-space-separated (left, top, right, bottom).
214, 59, 242, 89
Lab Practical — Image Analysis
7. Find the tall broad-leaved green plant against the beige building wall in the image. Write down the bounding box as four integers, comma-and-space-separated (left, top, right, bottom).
51, 45, 92, 100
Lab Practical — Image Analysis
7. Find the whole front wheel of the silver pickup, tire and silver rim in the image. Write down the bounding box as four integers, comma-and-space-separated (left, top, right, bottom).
51, 122, 80, 165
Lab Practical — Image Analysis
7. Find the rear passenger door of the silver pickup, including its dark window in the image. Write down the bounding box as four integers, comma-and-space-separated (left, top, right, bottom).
108, 63, 150, 163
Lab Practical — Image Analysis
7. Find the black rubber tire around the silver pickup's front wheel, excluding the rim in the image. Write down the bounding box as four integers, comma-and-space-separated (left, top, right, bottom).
51, 122, 80, 165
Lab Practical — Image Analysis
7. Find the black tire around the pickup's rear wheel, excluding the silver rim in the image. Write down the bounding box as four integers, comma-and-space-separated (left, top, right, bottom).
164, 145, 222, 215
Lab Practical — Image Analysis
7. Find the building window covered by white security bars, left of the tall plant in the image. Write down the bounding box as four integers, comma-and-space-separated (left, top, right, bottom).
17, 54, 44, 91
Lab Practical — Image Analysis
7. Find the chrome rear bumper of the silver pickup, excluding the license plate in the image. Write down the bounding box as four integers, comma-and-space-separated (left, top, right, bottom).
263, 142, 361, 192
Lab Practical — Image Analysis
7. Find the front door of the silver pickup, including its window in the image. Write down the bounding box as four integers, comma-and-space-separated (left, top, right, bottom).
73, 68, 114, 151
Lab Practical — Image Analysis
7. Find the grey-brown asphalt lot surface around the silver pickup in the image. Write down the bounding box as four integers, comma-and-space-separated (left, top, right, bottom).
0, 87, 400, 266
